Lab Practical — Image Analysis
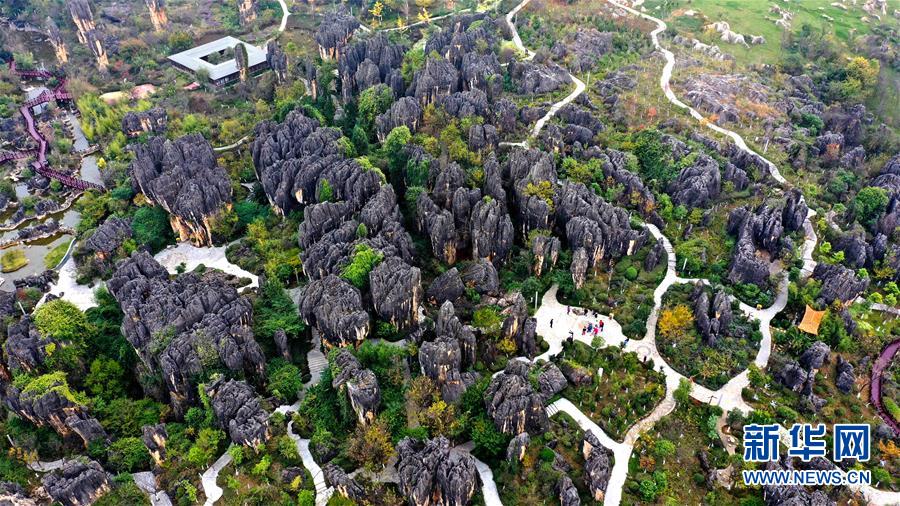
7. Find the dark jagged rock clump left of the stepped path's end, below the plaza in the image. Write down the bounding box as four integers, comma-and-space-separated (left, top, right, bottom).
484, 360, 549, 434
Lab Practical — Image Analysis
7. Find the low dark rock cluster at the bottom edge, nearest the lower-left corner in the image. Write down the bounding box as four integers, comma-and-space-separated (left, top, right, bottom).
41, 459, 112, 506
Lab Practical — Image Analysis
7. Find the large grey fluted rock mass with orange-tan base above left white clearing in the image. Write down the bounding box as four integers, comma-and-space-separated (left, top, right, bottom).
131, 133, 231, 246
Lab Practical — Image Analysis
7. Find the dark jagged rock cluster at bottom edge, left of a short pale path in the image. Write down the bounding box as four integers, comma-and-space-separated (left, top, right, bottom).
397, 436, 479, 506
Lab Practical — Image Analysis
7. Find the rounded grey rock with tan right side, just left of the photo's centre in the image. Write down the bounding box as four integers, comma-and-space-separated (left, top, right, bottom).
369, 257, 422, 329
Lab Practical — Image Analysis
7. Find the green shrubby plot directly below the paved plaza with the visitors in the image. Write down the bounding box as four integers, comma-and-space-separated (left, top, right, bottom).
554, 341, 666, 441
